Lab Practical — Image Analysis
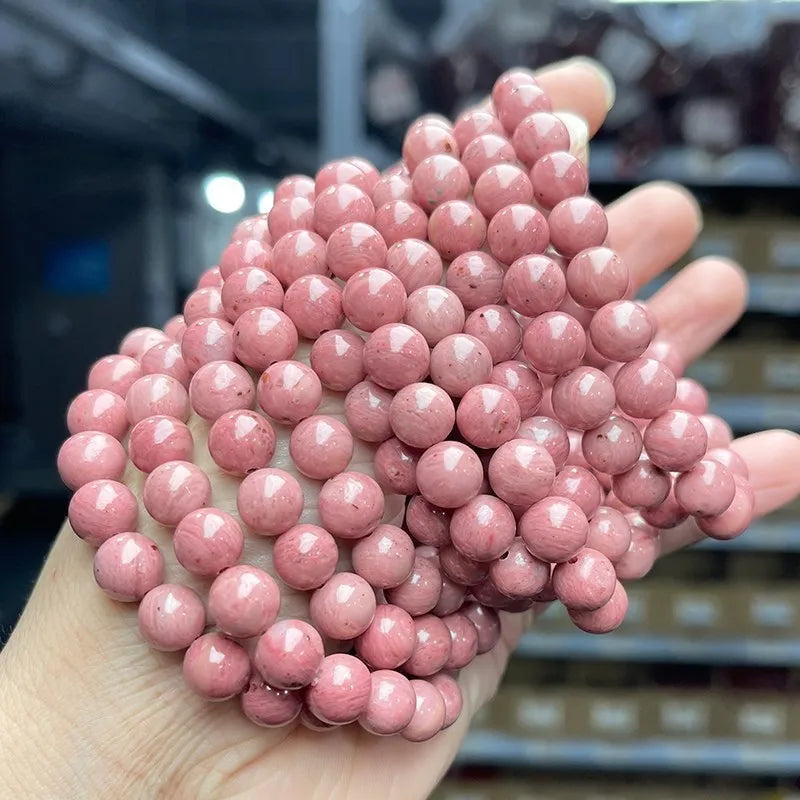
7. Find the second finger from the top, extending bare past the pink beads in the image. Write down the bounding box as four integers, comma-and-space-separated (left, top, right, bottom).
606, 182, 702, 294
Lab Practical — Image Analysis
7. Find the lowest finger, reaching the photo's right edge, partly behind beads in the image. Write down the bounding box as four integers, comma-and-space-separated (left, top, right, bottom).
661, 430, 800, 555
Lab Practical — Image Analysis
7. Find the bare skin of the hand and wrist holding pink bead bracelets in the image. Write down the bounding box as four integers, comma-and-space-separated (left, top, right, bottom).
0, 60, 800, 800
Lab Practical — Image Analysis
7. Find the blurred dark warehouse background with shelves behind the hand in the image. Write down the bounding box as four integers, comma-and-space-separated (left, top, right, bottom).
0, 0, 800, 800
